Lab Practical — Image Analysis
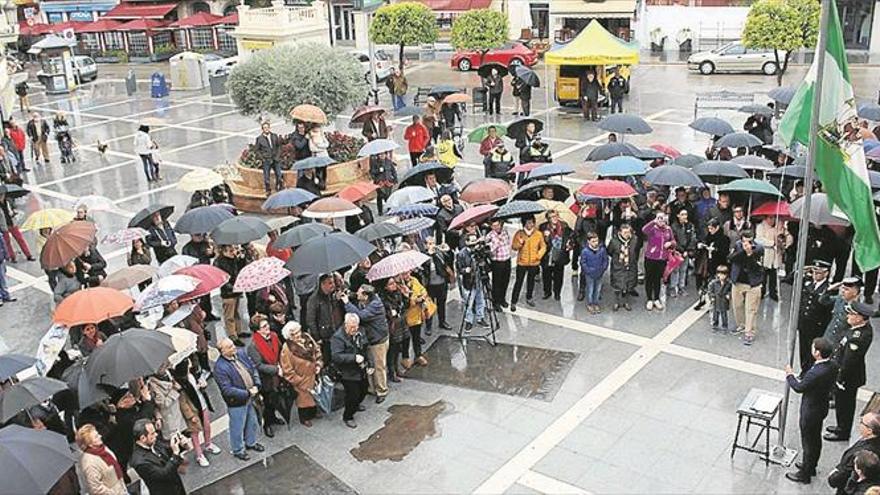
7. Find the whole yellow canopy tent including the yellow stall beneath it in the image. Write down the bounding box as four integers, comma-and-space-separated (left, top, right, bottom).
544, 20, 639, 105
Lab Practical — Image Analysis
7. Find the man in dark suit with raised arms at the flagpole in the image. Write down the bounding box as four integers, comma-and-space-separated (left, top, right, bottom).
785, 337, 837, 484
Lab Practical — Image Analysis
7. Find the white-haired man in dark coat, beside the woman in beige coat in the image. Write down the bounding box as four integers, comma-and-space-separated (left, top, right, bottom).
330, 313, 373, 428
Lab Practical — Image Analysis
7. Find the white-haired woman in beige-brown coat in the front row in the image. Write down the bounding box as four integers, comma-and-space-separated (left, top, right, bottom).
280, 321, 322, 426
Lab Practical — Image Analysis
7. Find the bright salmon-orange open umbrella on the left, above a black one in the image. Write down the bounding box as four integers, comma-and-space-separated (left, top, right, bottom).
52, 288, 134, 327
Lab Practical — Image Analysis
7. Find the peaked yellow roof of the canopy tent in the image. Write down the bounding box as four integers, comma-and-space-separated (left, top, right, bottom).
544, 19, 639, 65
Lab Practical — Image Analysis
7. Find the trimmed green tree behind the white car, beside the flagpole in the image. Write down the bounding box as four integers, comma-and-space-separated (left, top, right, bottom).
743, 0, 821, 86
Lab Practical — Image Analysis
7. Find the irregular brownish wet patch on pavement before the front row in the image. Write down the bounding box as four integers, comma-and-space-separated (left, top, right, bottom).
351, 400, 447, 462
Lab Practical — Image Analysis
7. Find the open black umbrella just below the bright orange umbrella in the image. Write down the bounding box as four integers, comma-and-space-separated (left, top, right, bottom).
85, 328, 176, 387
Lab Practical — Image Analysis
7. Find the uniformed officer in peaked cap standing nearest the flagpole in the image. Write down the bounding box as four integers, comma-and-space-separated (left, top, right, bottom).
798, 260, 832, 376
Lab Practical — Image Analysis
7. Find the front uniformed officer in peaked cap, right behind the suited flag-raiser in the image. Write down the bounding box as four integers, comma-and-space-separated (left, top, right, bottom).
824, 302, 874, 442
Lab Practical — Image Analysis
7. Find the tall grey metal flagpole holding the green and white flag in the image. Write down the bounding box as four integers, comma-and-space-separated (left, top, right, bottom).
771, 0, 841, 466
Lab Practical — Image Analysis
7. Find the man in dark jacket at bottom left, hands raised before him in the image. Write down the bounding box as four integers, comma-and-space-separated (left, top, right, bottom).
131, 419, 186, 495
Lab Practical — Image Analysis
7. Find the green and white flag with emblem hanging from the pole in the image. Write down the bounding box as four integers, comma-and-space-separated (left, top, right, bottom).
779, 1, 880, 271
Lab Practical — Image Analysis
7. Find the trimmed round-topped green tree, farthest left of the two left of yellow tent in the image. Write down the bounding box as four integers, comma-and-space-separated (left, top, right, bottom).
370, 2, 439, 70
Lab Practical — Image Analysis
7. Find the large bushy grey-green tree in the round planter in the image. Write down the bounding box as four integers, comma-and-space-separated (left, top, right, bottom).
227, 43, 368, 118
